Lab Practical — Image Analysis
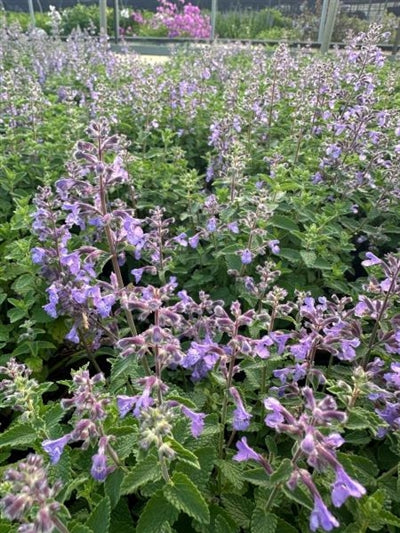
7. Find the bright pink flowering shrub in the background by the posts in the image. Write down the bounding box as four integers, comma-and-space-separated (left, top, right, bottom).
153, 0, 211, 39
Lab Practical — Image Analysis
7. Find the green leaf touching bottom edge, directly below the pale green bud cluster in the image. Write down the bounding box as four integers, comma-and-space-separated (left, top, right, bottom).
136, 491, 179, 533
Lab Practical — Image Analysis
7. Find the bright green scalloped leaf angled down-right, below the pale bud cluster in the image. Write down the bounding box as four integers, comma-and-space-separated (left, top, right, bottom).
164, 472, 210, 524
